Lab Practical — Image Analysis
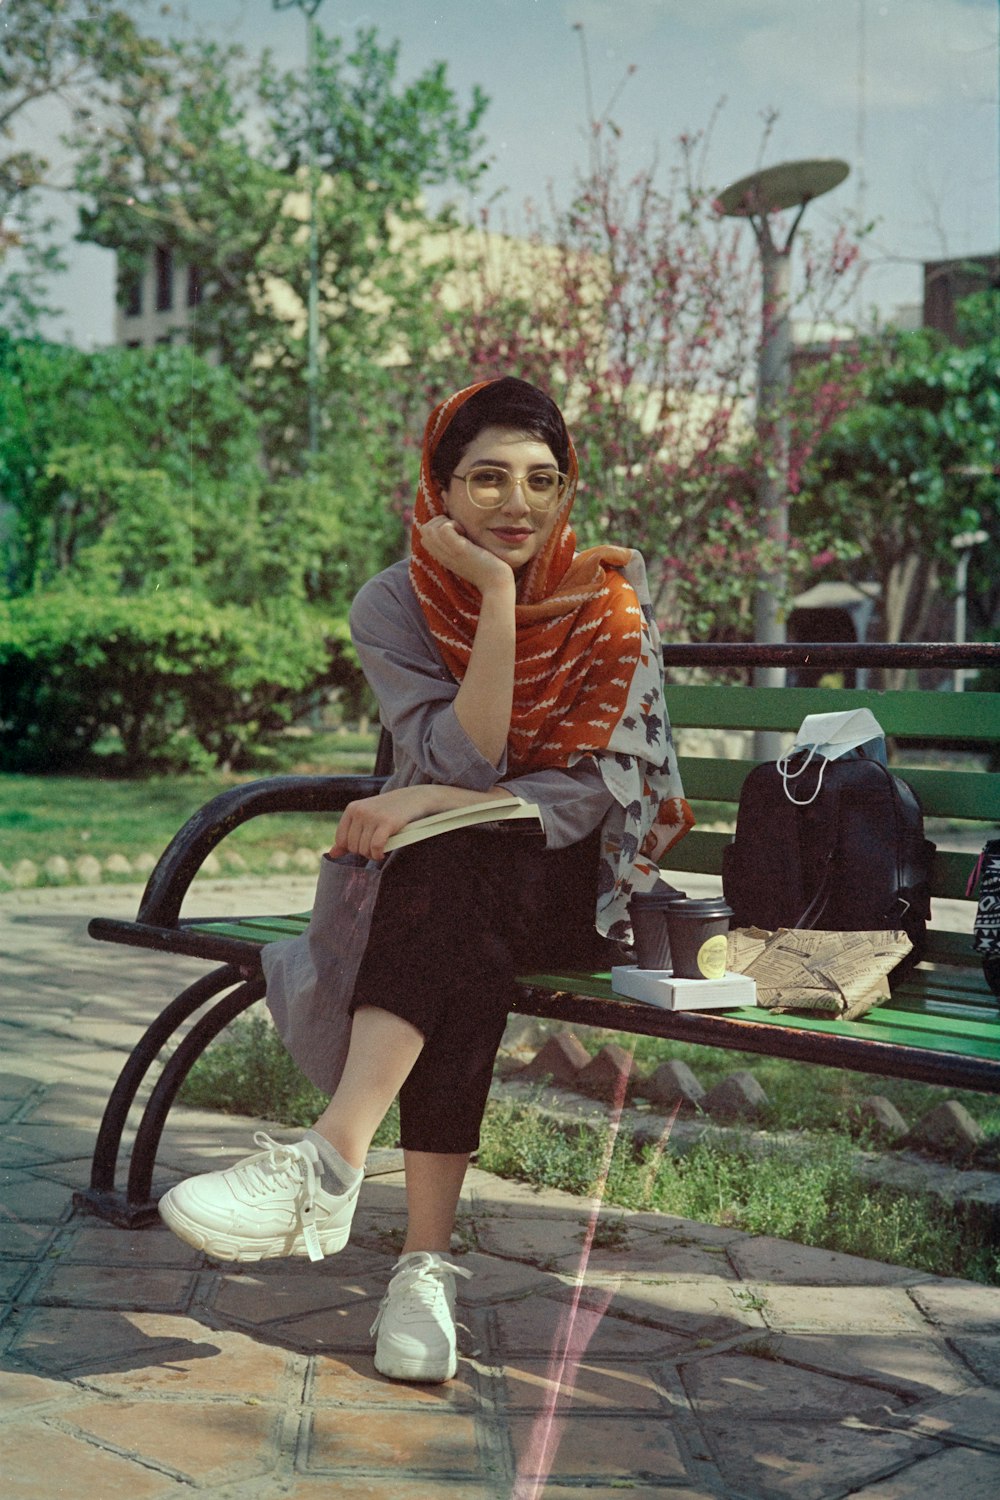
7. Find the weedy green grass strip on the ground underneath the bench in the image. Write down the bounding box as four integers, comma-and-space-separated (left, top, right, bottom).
181, 1016, 1000, 1286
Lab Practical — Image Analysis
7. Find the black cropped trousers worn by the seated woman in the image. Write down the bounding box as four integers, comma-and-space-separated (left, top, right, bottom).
352, 828, 618, 1152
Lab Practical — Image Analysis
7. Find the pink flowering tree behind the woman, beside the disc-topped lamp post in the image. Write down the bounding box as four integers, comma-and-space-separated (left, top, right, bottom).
427, 109, 858, 639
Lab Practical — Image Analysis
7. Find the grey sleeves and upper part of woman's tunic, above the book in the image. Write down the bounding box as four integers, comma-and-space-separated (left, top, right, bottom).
351, 561, 613, 849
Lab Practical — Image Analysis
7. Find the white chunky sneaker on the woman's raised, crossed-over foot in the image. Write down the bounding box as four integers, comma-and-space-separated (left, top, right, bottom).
159, 1131, 363, 1260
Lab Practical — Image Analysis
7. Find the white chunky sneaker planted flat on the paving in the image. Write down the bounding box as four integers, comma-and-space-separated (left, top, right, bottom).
372, 1250, 472, 1382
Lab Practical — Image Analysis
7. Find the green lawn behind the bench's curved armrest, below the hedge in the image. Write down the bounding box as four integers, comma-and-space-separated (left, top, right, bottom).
0, 735, 375, 875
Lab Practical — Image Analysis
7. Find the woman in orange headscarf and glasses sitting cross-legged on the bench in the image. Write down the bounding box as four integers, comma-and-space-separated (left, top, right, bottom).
160, 378, 691, 1380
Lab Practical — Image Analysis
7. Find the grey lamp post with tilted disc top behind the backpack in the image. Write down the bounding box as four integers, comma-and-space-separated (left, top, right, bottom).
717, 159, 850, 761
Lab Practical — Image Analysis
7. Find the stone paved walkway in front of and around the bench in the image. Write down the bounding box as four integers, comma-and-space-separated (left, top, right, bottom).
0, 881, 1000, 1500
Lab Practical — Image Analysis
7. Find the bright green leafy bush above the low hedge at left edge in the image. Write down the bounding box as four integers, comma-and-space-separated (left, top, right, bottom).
0, 340, 261, 594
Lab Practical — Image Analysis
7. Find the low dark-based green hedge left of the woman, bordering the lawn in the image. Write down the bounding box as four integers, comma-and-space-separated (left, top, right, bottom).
0, 590, 358, 774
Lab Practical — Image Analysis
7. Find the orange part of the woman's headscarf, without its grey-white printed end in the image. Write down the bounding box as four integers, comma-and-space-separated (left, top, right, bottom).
409, 381, 642, 771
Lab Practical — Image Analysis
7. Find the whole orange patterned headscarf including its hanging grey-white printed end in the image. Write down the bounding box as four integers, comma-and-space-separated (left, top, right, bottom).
409, 381, 694, 941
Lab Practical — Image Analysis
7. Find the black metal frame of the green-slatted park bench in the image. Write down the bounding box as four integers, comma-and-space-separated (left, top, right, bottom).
75, 644, 1000, 1227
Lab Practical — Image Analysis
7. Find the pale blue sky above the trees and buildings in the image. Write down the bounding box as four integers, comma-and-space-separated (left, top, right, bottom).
21, 0, 1000, 348
